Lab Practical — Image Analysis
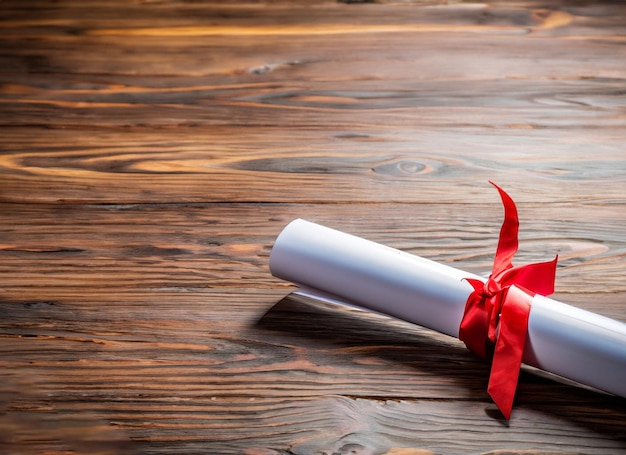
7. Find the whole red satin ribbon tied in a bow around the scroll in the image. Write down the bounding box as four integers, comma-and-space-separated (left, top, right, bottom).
459, 182, 558, 419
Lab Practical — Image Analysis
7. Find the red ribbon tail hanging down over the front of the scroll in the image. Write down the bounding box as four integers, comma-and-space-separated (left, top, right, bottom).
487, 286, 532, 420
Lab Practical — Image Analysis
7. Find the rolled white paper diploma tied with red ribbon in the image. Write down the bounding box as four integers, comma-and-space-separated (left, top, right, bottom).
270, 219, 626, 397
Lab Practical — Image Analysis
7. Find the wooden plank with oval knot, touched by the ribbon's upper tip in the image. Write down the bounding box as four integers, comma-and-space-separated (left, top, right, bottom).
0, 126, 626, 204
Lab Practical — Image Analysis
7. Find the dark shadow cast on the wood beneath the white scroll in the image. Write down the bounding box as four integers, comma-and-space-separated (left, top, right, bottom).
257, 293, 626, 438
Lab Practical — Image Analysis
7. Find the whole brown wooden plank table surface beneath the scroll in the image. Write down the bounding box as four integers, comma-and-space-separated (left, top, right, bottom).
0, 0, 626, 455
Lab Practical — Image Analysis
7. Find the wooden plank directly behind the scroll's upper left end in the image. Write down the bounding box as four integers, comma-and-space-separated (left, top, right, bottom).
0, 200, 626, 302
